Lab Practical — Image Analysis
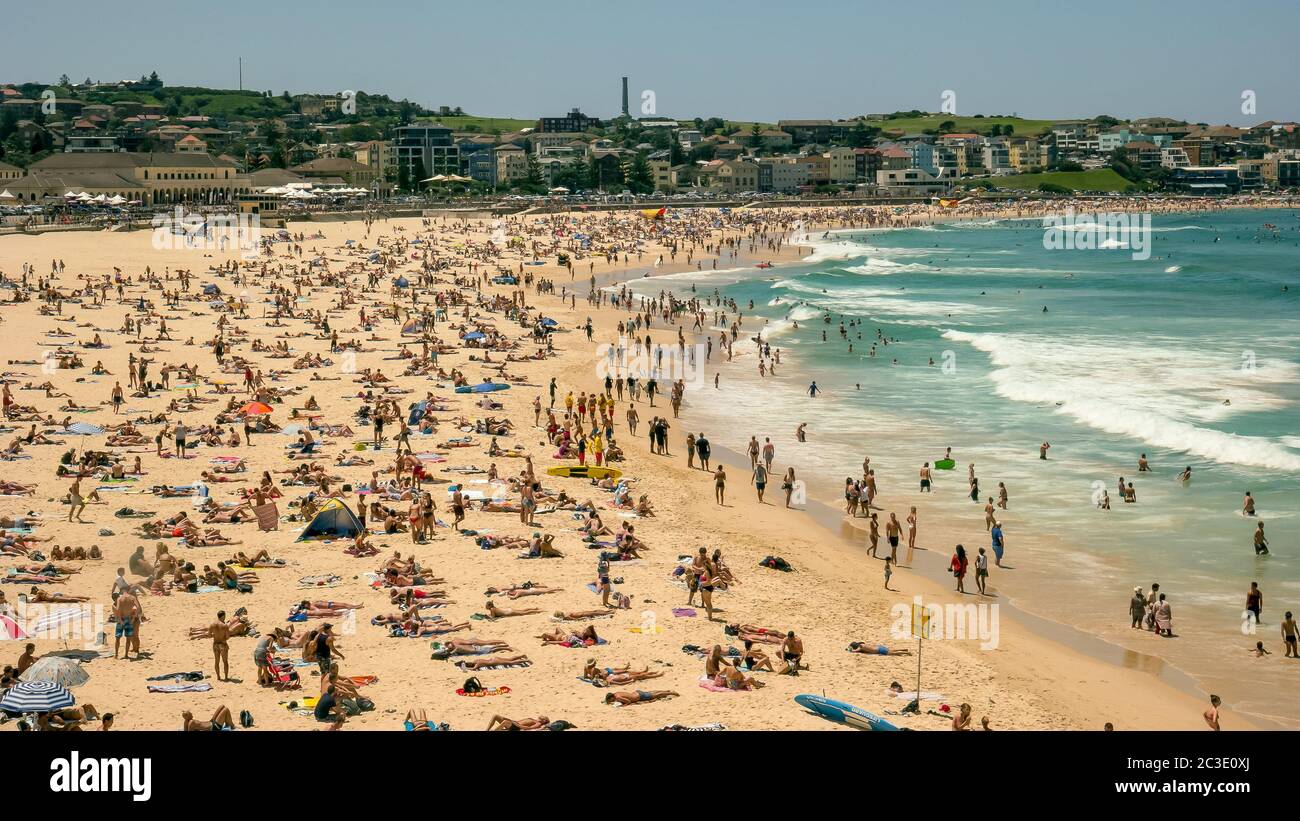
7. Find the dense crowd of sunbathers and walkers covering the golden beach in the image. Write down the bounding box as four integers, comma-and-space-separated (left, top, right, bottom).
0, 193, 1296, 731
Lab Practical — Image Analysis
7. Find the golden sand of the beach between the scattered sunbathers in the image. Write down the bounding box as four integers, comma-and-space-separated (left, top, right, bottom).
0, 203, 1249, 731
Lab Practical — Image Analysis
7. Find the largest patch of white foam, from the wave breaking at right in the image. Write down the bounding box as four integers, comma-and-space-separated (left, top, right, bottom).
944, 330, 1300, 470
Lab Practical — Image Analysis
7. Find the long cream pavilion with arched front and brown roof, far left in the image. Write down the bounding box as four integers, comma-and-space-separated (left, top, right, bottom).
5, 152, 252, 205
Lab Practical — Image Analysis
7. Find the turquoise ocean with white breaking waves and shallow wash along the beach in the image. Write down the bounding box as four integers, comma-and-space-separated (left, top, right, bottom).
618, 209, 1300, 726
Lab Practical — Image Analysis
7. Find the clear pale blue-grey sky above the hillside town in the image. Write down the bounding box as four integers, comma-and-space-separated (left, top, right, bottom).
0, 0, 1300, 125
